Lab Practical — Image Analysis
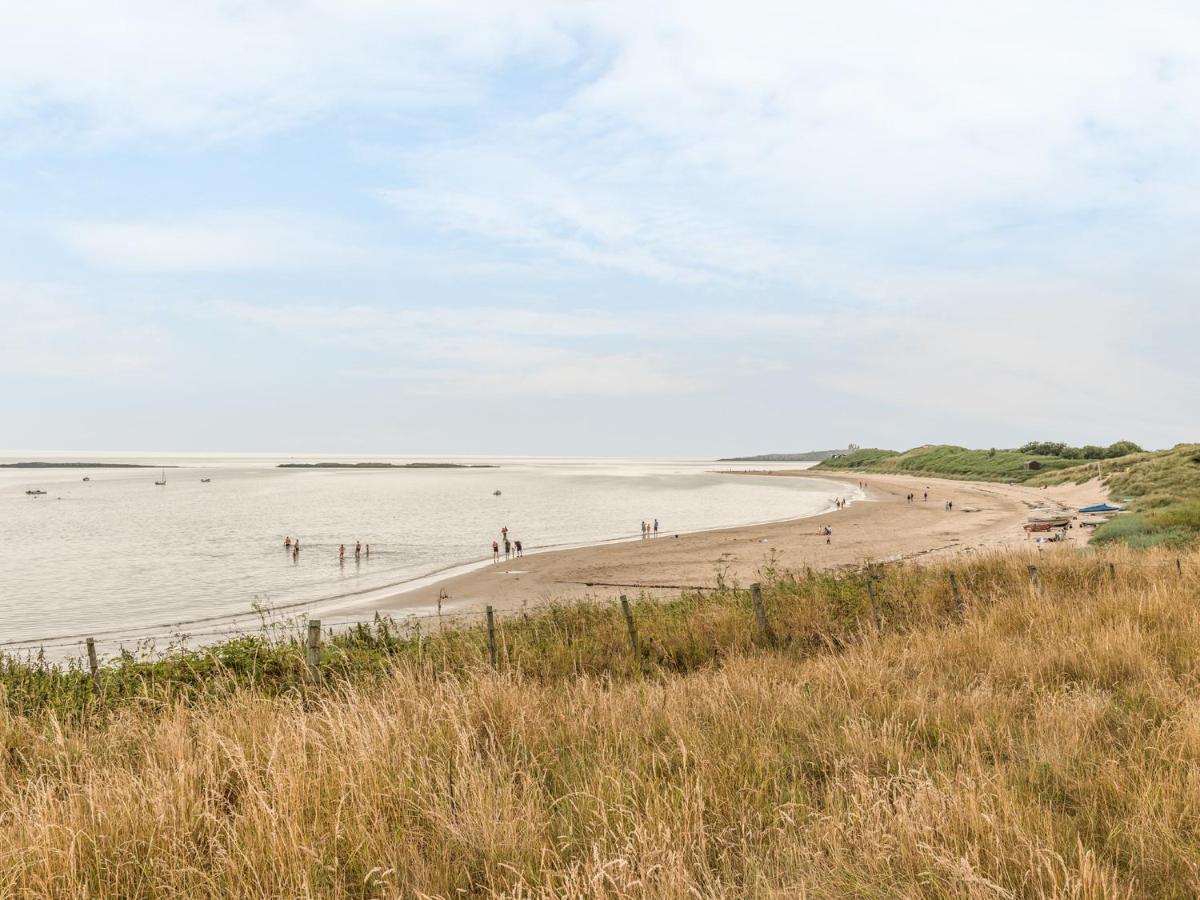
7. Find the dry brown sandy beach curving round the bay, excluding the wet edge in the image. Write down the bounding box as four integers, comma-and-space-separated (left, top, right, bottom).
346, 470, 1106, 617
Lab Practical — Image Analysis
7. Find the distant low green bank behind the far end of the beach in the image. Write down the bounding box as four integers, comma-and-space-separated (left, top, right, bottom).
815, 444, 1078, 482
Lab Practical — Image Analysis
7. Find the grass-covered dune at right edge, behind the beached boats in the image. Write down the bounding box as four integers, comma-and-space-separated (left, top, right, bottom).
1036, 444, 1200, 548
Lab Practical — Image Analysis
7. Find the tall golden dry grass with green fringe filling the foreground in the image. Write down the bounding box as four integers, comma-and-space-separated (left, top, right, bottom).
0, 550, 1200, 898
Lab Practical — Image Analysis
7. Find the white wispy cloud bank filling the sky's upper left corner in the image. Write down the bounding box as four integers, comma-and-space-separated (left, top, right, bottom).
0, 0, 569, 144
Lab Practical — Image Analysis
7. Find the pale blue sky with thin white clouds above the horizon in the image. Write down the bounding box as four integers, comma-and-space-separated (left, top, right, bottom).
0, 0, 1200, 456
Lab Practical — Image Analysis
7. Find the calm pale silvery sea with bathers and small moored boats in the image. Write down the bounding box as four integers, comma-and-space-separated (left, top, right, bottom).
0, 456, 850, 655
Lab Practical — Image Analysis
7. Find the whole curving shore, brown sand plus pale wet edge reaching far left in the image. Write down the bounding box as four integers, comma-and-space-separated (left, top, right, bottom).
0, 468, 1106, 658
